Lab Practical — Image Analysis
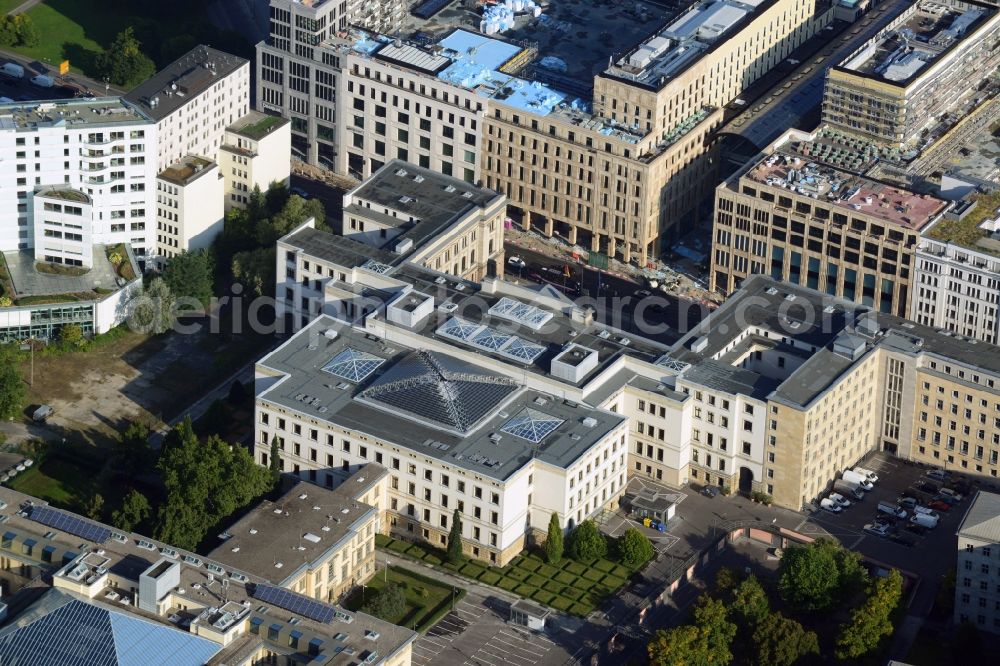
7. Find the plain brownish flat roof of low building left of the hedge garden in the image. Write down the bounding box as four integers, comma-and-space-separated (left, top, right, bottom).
208, 463, 386, 586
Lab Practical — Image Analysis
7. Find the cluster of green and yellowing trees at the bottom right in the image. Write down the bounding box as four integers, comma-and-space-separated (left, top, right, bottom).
647, 539, 902, 666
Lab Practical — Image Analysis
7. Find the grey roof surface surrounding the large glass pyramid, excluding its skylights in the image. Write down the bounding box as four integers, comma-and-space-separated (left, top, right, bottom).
258, 315, 624, 480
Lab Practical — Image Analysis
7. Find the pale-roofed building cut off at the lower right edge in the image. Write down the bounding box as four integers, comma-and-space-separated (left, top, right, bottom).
955, 490, 1000, 635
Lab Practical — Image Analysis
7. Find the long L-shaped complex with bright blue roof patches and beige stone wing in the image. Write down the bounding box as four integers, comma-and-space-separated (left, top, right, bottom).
257, 0, 832, 265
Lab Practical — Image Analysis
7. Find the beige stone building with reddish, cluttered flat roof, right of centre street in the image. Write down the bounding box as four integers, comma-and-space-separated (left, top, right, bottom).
710, 129, 948, 316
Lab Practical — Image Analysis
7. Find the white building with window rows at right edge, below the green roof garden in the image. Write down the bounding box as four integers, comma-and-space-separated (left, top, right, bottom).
909, 213, 1000, 344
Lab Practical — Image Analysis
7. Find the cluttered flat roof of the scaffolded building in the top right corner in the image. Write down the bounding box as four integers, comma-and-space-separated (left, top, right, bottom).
840, 0, 996, 85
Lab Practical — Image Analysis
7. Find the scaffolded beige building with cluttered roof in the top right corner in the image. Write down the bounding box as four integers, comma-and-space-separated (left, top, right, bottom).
823, 0, 1000, 145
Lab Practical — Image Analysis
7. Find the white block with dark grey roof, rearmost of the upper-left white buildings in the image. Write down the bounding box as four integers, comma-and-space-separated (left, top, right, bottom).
123, 46, 250, 171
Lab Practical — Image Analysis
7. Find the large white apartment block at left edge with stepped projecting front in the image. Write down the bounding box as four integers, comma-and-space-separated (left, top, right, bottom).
0, 98, 157, 267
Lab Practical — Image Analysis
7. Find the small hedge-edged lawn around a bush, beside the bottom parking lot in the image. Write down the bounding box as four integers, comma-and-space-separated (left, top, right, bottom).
343, 566, 465, 631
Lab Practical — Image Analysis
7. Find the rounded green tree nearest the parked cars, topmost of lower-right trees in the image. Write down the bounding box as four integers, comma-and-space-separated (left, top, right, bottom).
778, 539, 866, 612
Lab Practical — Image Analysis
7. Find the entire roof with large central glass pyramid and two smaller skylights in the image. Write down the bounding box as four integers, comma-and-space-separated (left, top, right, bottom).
257, 315, 624, 480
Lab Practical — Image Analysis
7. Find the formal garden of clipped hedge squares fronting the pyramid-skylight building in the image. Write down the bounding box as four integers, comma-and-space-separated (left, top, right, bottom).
375, 535, 642, 617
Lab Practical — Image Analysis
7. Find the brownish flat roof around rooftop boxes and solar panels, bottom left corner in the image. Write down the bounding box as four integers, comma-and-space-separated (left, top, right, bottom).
0, 487, 417, 664
